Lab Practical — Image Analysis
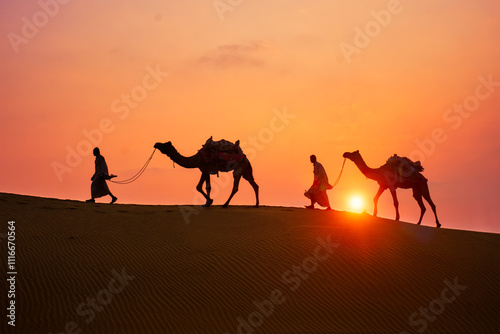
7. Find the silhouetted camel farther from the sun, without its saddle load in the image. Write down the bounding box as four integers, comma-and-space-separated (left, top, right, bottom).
154, 142, 259, 207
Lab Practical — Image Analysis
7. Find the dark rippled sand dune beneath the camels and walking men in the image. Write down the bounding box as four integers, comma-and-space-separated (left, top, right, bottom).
0, 194, 500, 333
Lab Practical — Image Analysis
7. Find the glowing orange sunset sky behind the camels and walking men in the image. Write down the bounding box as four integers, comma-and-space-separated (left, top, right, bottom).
0, 0, 500, 233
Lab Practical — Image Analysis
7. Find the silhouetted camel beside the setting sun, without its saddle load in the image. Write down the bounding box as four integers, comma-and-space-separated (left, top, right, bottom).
343, 151, 441, 227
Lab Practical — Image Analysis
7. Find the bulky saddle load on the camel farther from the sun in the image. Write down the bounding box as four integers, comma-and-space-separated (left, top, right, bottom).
199, 137, 246, 164
